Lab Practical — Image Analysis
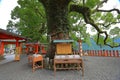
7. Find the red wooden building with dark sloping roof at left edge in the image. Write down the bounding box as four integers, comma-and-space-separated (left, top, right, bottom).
0, 29, 26, 60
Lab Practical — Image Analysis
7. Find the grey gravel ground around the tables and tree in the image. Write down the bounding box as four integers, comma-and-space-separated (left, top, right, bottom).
0, 55, 120, 80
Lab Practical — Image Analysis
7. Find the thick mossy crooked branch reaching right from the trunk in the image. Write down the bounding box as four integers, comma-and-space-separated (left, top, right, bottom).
70, 5, 108, 44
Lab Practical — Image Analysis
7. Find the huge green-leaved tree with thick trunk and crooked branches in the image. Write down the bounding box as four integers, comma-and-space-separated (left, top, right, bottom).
8, 0, 120, 58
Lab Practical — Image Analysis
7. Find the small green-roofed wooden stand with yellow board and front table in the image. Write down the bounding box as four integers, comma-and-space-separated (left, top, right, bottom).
53, 40, 84, 75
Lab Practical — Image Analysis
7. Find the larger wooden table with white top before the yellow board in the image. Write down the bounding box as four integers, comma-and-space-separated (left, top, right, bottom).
54, 55, 84, 76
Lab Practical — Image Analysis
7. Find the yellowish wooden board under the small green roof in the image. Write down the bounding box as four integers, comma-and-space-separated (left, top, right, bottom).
56, 43, 72, 55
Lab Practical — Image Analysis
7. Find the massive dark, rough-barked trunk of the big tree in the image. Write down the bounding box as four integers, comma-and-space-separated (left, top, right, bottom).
39, 0, 70, 58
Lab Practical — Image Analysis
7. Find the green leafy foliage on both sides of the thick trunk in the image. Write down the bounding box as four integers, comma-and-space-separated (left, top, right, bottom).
7, 0, 120, 47
